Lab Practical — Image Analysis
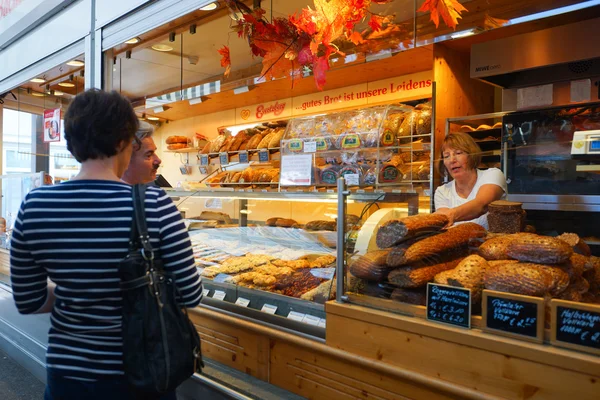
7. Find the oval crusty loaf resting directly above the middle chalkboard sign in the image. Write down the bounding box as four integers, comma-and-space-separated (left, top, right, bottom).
483, 263, 554, 297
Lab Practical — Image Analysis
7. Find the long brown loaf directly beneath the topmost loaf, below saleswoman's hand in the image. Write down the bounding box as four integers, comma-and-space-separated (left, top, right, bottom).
387, 222, 485, 266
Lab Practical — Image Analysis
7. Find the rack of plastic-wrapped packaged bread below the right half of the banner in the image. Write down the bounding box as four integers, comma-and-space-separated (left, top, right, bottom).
281, 100, 433, 194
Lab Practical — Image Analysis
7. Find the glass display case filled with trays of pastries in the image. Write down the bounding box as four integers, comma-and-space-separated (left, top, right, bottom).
168, 189, 418, 338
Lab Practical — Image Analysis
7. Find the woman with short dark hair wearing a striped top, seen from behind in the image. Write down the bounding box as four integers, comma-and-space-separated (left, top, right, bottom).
10, 90, 202, 400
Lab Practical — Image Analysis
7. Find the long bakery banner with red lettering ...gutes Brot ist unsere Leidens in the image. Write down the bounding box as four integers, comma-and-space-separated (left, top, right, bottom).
235, 71, 433, 125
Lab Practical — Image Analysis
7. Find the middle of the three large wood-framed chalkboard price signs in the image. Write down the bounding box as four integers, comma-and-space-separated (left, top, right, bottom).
482, 290, 544, 343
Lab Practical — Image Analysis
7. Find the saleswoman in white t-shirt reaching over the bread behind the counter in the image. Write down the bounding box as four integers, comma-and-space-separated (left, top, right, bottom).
434, 132, 507, 229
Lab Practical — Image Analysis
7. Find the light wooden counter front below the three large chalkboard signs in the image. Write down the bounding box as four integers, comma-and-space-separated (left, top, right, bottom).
326, 302, 600, 400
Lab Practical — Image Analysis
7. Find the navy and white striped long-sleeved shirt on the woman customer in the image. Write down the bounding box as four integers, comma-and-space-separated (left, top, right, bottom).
10, 180, 202, 380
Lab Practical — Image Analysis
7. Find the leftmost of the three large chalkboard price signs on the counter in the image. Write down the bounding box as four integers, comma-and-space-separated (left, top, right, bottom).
427, 283, 471, 328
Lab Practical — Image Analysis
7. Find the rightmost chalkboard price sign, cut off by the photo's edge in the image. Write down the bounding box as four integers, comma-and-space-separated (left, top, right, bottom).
551, 300, 600, 354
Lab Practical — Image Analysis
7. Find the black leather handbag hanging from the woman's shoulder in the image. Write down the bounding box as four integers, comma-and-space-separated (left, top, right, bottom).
119, 185, 203, 396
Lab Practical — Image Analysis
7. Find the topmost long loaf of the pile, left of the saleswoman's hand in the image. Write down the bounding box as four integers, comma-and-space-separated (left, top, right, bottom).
376, 214, 448, 249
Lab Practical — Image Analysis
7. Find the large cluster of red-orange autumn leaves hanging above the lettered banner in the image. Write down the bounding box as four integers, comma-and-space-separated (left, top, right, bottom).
219, 0, 391, 90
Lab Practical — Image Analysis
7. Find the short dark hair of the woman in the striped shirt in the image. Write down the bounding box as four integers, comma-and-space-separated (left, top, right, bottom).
65, 89, 139, 162
